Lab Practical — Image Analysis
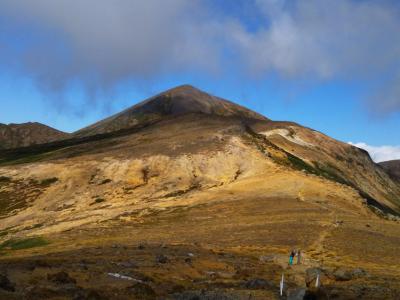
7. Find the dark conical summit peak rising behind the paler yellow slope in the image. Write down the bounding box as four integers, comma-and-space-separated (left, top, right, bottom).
75, 85, 268, 136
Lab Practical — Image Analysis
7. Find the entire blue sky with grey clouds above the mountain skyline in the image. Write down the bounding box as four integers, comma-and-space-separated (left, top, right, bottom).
0, 0, 400, 162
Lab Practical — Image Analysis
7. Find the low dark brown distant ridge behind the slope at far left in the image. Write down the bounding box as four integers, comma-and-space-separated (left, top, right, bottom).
0, 123, 69, 149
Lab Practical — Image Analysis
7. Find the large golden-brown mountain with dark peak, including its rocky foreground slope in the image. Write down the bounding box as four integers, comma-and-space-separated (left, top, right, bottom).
0, 86, 400, 299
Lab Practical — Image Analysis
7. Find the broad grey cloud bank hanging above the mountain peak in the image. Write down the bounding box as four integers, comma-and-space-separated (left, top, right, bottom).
0, 0, 400, 113
